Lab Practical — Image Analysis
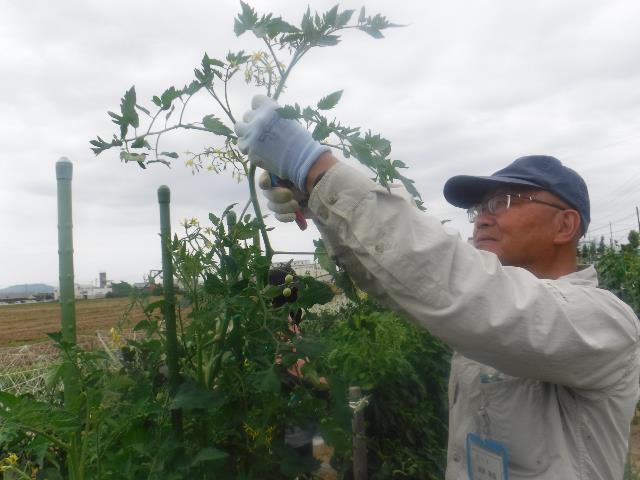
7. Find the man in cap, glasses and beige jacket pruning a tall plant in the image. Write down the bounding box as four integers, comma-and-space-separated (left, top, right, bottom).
236, 97, 640, 480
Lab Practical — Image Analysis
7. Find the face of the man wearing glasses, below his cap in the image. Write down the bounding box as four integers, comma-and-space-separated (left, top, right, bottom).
473, 187, 569, 273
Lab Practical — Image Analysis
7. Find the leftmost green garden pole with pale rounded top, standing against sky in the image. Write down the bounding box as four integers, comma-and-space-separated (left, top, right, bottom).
56, 157, 80, 407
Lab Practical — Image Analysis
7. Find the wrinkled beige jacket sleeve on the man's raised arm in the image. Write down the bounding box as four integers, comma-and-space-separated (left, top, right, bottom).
310, 163, 638, 389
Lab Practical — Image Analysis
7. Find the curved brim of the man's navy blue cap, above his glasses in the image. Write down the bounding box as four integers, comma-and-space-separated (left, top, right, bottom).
444, 175, 542, 208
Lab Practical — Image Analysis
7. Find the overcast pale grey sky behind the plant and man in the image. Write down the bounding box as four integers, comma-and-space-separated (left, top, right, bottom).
0, 0, 640, 287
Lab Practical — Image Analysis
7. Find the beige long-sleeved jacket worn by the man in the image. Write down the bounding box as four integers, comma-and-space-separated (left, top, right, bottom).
310, 164, 640, 480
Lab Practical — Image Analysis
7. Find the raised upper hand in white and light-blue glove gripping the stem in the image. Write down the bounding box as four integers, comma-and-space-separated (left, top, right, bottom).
234, 95, 330, 192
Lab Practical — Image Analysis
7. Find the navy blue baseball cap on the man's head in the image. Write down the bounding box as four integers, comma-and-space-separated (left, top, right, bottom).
444, 155, 591, 235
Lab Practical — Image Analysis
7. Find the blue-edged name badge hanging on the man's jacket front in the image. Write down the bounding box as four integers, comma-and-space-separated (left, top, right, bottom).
467, 433, 509, 480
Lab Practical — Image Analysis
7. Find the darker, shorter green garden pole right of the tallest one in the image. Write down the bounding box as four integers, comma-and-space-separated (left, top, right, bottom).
158, 185, 182, 435
